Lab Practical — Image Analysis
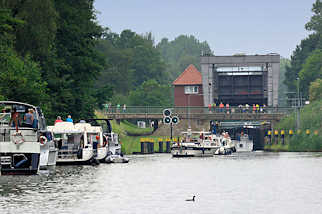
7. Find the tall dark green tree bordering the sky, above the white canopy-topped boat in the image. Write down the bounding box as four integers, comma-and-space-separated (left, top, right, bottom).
45, 0, 104, 119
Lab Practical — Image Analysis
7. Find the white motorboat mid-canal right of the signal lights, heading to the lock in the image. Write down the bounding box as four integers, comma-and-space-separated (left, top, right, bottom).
171, 130, 215, 157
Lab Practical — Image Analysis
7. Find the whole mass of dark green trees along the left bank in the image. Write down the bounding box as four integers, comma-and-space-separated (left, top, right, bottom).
0, 0, 105, 123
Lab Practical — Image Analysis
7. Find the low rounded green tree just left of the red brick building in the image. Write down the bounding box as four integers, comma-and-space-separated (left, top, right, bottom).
129, 79, 171, 106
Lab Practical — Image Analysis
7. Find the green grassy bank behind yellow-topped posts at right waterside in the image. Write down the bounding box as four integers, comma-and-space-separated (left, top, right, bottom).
265, 100, 322, 152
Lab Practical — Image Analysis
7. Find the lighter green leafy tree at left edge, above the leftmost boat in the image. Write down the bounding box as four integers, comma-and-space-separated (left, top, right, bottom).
0, 5, 48, 106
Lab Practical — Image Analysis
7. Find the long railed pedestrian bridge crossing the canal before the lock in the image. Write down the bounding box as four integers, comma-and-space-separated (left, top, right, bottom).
100, 106, 295, 122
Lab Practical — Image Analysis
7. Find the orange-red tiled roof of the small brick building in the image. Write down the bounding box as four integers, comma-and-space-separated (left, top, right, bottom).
172, 64, 202, 85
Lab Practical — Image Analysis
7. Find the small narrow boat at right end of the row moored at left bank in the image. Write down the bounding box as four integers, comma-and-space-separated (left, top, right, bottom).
104, 132, 129, 163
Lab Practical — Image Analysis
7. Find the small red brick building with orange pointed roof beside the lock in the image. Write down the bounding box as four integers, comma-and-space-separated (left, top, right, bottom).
172, 65, 203, 106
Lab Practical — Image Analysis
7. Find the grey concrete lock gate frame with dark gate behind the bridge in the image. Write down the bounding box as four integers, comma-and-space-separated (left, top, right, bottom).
201, 54, 280, 107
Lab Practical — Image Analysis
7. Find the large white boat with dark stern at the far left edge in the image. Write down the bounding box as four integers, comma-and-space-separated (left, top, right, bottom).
0, 101, 46, 175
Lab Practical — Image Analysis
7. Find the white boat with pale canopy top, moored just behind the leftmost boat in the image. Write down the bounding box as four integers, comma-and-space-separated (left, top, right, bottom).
47, 122, 97, 165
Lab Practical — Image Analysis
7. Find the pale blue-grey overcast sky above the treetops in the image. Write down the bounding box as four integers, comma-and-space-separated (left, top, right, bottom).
95, 0, 315, 58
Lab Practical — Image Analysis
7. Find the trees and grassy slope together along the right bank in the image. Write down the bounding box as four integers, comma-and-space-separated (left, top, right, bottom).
265, 0, 322, 151
